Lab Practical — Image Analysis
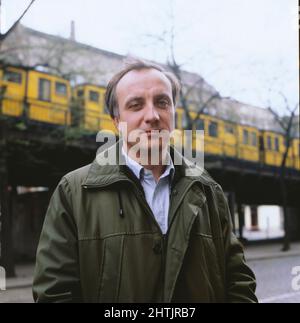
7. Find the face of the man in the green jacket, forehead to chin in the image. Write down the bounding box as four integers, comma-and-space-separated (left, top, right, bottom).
114, 69, 175, 159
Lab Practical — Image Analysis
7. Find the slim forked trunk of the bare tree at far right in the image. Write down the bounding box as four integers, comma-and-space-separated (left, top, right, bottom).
268, 92, 299, 251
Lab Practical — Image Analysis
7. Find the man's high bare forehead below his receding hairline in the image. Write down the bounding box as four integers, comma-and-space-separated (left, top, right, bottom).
116, 69, 172, 98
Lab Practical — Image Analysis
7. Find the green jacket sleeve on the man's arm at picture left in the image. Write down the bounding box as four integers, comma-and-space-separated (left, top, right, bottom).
33, 178, 81, 303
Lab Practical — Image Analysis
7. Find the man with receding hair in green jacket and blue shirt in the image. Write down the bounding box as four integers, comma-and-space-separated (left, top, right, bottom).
33, 61, 257, 302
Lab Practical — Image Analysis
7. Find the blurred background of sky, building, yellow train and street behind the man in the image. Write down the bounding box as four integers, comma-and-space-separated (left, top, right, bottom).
0, 0, 300, 302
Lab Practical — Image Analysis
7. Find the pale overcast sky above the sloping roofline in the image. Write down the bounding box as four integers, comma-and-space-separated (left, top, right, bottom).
2, 0, 299, 111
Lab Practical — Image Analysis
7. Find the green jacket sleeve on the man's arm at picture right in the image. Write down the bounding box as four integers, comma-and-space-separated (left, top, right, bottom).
217, 186, 258, 303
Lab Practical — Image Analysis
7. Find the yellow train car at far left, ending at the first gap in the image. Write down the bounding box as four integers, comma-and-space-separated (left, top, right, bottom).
0, 66, 71, 125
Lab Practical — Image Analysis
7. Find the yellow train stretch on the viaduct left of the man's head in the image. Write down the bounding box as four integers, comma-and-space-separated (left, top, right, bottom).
0, 66, 115, 131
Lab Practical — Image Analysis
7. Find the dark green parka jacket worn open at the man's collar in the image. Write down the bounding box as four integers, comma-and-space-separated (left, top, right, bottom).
33, 145, 257, 303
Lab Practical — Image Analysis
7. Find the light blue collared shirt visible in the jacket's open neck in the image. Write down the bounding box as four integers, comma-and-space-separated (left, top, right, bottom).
122, 149, 175, 234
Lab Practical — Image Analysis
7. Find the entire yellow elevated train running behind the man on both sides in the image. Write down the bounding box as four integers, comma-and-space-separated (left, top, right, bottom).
0, 66, 300, 170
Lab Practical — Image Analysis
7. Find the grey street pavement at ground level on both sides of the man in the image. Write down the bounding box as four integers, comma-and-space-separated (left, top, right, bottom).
0, 243, 300, 303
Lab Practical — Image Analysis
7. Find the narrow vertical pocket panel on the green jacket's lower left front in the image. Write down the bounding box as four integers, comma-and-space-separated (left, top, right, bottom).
98, 235, 124, 303
